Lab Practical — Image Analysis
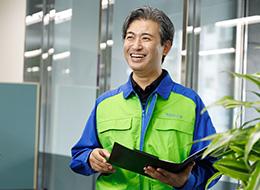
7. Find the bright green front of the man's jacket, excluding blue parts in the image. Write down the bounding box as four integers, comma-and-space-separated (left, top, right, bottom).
96, 93, 196, 190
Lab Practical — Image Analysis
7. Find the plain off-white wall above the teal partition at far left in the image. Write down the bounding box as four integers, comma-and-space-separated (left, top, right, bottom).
0, 0, 26, 82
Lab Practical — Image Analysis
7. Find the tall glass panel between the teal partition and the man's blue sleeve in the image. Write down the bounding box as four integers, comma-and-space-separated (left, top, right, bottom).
48, 0, 99, 160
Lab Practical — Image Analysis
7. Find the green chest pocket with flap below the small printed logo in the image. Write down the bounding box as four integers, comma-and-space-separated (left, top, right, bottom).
147, 118, 194, 162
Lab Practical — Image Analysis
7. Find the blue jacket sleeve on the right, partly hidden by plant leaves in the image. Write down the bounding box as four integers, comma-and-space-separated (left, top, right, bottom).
176, 97, 218, 190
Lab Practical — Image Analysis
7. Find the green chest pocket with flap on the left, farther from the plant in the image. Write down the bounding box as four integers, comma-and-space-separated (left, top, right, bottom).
97, 118, 136, 151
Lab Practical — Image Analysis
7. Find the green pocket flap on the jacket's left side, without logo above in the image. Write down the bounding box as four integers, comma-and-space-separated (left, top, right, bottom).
98, 118, 131, 133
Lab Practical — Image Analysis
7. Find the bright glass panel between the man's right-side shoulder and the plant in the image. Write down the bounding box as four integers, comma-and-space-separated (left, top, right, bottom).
197, 0, 237, 132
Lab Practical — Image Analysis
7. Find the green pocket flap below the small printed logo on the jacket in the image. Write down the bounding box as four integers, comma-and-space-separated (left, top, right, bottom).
154, 118, 194, 135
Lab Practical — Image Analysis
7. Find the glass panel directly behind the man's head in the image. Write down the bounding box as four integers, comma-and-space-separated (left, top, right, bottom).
111, 0, 183, 88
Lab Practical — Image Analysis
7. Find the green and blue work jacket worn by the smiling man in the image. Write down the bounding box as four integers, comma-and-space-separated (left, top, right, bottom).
70, 74, 218, 190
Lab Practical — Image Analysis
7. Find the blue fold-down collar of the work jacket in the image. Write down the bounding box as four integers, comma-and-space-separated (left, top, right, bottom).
121, 73, 174, 99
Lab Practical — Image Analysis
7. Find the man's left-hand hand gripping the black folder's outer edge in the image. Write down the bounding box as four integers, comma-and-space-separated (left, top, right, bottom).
89, 148, 115, 173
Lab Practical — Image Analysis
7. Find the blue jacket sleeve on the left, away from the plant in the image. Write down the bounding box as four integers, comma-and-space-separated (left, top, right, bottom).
70, 106, 101, 175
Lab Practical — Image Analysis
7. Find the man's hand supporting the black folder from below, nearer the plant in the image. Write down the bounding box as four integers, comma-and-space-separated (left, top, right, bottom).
144, 162, 195, 188
